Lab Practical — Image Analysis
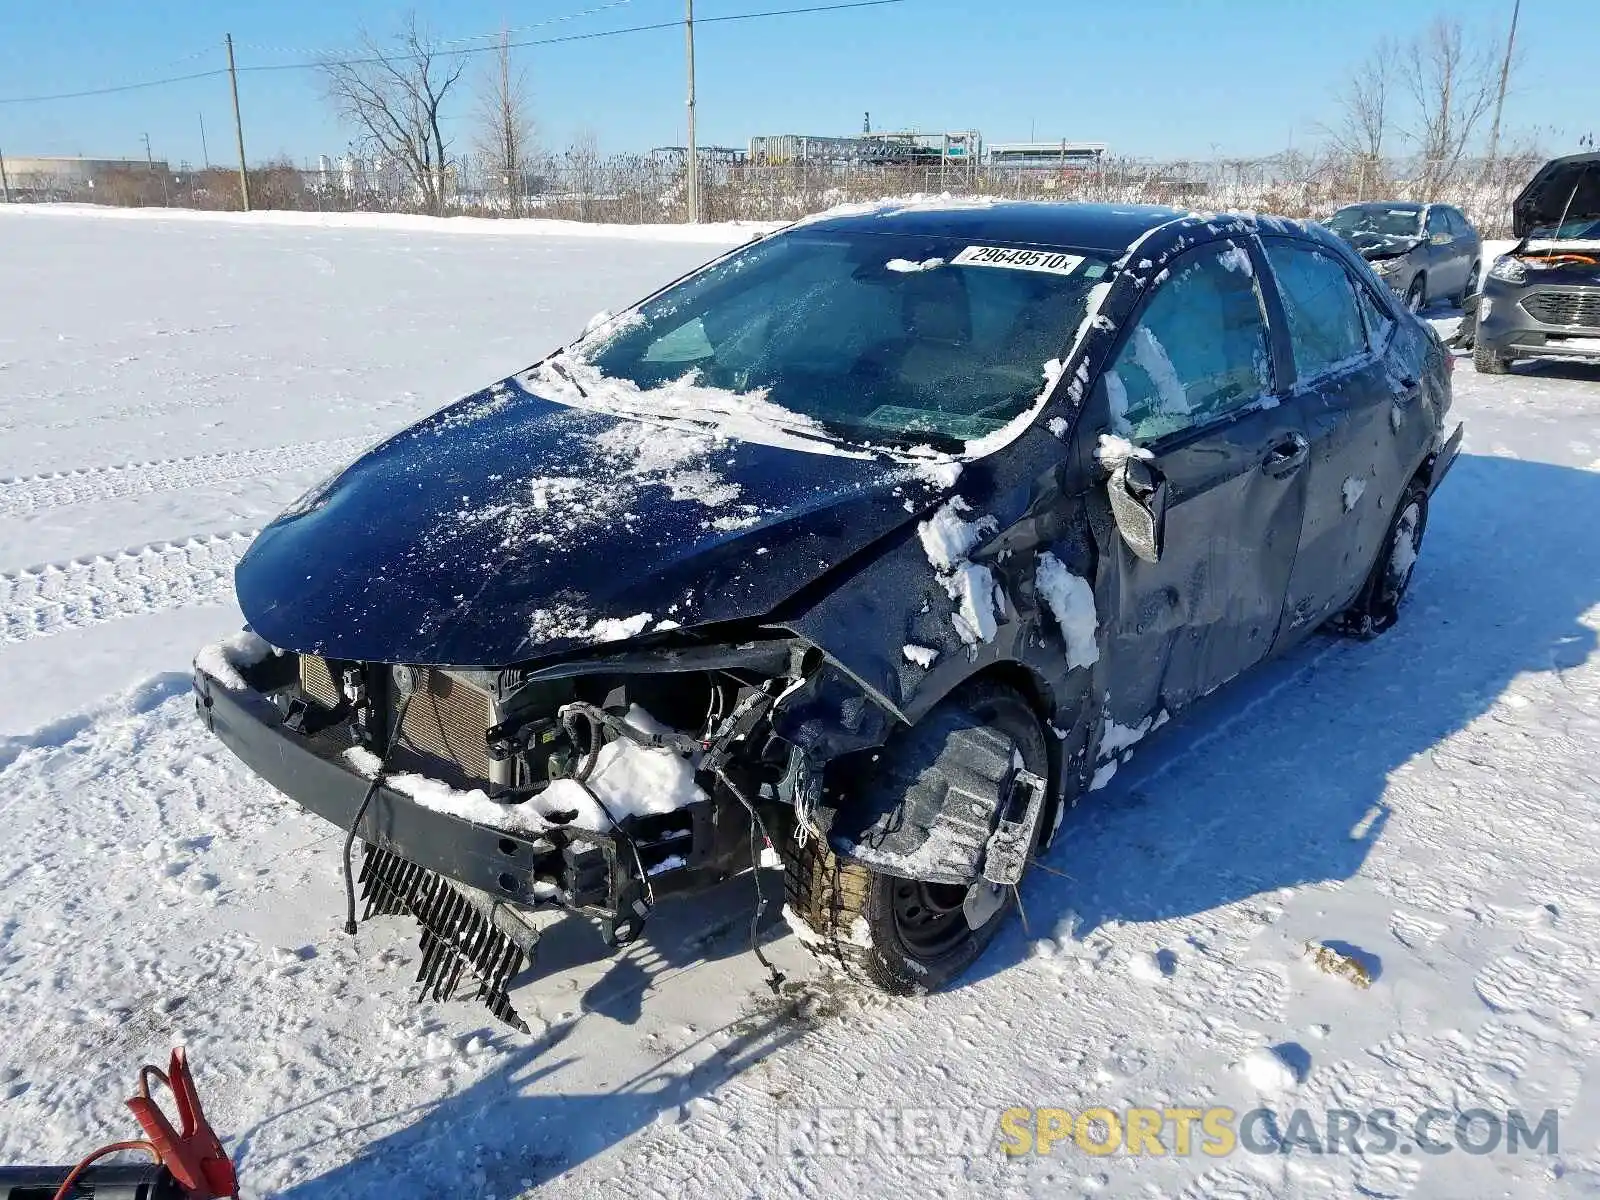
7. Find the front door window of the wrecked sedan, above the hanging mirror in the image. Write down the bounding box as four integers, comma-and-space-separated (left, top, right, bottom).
1106, 246, 1272, 442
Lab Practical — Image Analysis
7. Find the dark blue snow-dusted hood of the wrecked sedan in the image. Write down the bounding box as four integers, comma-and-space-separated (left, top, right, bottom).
235, 379, 950, 667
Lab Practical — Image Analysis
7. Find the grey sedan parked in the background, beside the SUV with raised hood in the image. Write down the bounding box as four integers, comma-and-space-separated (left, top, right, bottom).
1326, 200, 1483, 312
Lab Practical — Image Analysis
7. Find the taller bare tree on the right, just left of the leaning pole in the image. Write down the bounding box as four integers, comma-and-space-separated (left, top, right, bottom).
1405, 18, 1499, 200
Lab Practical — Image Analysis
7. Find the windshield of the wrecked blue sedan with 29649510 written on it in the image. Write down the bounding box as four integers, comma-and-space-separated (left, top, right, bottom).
563, 229, 1110, 451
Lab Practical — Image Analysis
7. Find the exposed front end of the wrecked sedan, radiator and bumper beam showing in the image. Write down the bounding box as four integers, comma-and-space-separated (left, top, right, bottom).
197, 635, 998, 1029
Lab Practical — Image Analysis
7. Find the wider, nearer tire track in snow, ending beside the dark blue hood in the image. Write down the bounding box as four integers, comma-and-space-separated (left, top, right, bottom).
0, 530, 259, 645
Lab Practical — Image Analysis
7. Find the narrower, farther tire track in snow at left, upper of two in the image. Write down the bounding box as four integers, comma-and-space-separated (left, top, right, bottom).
0, 437, 373, 517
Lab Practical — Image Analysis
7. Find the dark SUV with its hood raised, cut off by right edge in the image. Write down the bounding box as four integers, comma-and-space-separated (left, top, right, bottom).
1472, 154, 1600, 374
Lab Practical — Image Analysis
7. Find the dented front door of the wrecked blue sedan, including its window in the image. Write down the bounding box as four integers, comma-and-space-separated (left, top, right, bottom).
1080, 233, 1309, 725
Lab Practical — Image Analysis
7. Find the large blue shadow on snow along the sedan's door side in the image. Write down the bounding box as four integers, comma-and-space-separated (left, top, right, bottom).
966, 454, 1600, 984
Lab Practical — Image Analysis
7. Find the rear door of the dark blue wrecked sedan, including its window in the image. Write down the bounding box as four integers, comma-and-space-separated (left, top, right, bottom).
1262, 240, 1414, 643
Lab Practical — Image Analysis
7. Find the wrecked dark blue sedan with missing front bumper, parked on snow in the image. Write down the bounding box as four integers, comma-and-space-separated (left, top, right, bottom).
195, 203, 1461, 1024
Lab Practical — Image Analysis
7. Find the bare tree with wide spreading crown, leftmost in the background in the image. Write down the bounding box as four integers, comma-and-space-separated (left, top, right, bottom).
322, 13, 467, 216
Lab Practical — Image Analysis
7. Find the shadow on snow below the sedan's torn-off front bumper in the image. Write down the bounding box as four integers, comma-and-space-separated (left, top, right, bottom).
267, 869, 810, 1200
